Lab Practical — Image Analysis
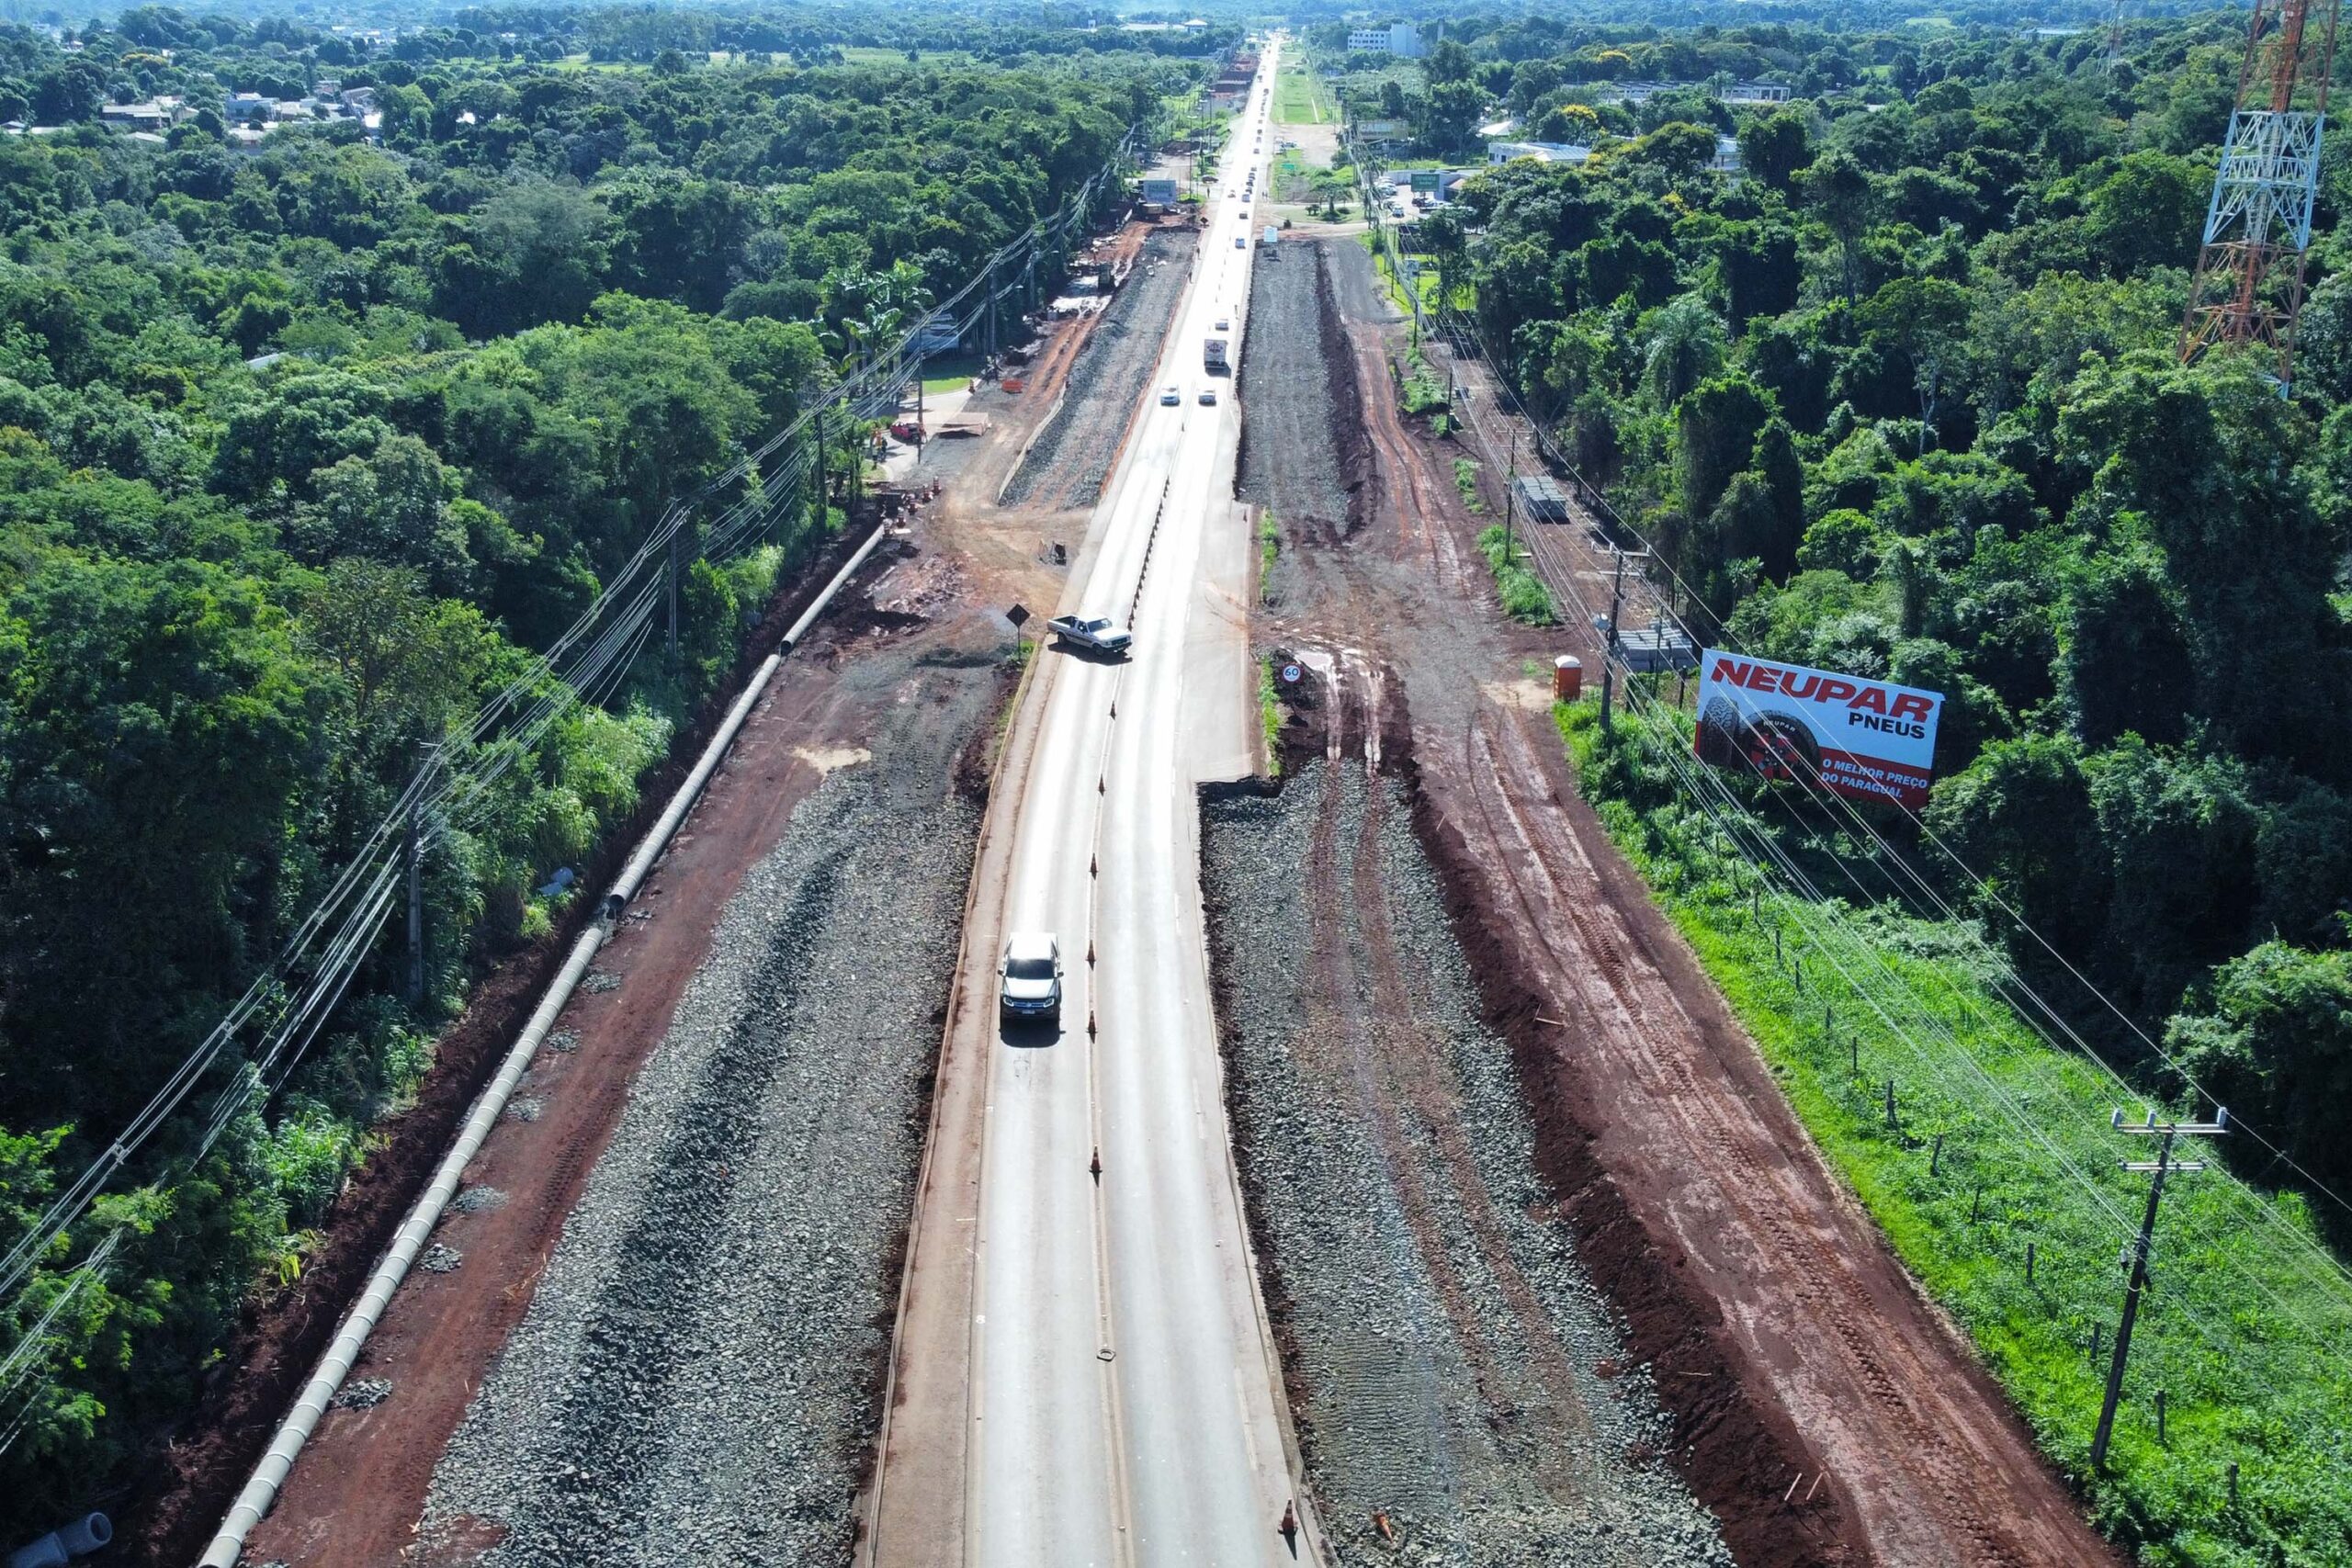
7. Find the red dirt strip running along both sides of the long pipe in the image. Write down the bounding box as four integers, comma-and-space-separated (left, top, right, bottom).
120, 529, 955, 1568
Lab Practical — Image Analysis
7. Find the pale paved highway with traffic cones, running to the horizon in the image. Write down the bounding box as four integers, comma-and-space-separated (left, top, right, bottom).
868, 47, 1315, 1568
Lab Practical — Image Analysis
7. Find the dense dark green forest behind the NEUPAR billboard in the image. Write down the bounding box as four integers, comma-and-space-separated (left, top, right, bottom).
1360, 0, 2352, 1190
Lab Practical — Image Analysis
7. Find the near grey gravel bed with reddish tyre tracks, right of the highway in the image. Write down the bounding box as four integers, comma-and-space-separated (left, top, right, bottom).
1202, 760, 1731, 1568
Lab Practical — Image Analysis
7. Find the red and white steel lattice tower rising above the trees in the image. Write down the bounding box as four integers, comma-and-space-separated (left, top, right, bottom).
2180, 0, 2340, 390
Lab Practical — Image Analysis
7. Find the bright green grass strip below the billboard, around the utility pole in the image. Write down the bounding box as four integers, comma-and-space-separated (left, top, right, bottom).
1557, 701, 2352, 1568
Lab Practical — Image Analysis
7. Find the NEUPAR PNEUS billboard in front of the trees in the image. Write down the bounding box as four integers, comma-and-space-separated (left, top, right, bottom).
1698, 649, 1943, 808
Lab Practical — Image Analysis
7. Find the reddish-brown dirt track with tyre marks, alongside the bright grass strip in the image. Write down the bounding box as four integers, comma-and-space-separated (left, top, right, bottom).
1244, 243, 2114, 1568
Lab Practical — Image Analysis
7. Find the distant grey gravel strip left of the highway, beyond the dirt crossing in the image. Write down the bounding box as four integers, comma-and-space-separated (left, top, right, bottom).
1002, 228, 1200, 510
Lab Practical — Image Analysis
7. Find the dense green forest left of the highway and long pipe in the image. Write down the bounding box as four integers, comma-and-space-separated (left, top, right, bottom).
0, 7, 1185, 1538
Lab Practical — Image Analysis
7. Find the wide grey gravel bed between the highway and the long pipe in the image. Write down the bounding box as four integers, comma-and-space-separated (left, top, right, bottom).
425, 668, 992, 1568
